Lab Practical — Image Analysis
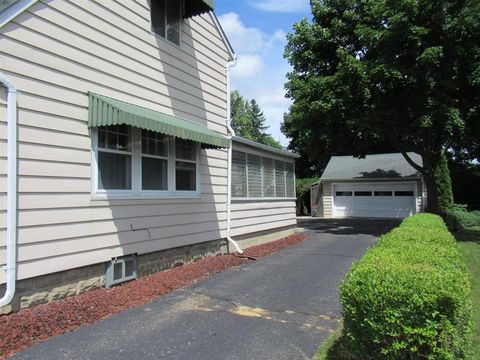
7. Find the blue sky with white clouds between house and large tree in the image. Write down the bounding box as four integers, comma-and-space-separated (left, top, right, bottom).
215, 0, 311, 145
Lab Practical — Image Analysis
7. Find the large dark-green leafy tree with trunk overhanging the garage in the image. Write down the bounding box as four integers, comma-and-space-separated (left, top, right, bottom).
282, 0, 480, 213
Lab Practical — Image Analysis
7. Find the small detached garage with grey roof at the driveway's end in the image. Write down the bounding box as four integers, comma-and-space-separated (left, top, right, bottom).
312, 153, 426, 218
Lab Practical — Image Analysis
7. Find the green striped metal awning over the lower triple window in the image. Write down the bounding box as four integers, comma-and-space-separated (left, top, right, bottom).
88, 92, 230, 148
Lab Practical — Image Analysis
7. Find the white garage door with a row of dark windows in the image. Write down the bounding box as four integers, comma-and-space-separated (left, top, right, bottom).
332, 183, 416, 218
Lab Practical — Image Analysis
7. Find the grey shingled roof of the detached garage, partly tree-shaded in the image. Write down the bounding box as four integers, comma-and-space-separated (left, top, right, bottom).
320, 152, 422, 180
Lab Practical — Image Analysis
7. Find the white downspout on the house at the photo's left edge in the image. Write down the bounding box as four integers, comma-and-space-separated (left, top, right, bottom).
0, 72, 17, 307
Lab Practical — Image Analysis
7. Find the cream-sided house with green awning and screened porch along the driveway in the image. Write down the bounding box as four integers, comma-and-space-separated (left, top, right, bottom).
0, 0, 296, 311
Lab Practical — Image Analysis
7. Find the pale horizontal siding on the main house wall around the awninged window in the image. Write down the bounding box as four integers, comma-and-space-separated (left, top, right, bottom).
0, 0, 229, 283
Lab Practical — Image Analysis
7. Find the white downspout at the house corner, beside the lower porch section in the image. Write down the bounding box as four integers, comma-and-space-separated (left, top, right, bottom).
226, 55, 243, 254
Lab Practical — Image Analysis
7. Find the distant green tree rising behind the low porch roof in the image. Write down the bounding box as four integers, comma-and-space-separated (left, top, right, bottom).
230, 90, 282, 149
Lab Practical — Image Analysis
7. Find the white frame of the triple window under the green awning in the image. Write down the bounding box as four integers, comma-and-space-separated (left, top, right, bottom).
90, 127, 202, 200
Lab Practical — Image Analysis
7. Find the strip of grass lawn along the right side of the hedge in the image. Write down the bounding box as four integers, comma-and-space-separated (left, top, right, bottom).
457, 231, 480, 360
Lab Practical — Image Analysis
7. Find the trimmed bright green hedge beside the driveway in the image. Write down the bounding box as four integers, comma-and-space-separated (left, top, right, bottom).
340, 214, 472, 360
